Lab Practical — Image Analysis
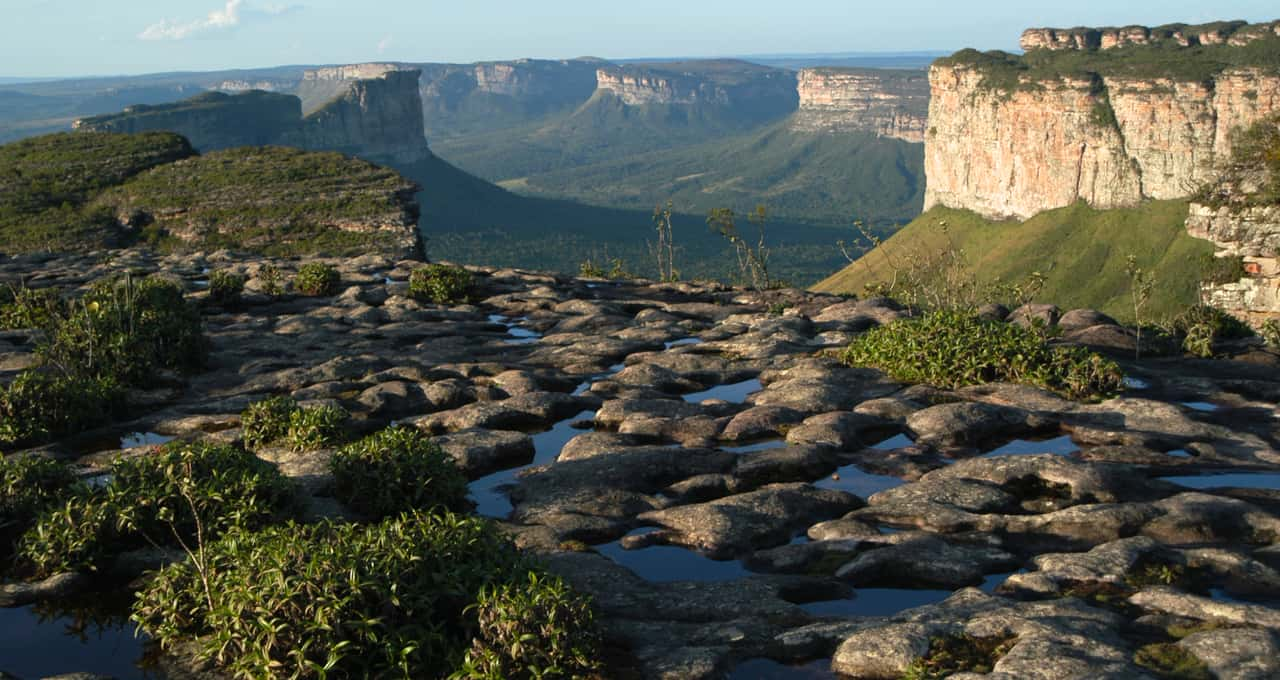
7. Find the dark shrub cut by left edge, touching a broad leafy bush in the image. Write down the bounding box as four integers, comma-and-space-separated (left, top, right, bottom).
0, 456, 76, 562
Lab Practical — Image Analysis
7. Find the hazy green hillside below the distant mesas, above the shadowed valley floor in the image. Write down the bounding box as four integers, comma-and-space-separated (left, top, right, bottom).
507, 122, 924, 224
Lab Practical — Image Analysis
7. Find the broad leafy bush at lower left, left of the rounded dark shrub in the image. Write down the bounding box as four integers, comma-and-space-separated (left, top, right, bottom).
19, 442, 294, 575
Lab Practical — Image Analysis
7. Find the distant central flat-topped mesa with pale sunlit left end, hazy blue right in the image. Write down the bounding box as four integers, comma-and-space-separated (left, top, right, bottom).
595, 59, 797, 113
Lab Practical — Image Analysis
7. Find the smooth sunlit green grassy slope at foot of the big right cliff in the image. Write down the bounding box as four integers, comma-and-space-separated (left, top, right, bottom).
814, 201, 1213, 319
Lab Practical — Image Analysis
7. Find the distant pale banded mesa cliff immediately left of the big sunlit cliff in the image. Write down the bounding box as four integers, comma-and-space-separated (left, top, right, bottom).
791, 68, 929, 142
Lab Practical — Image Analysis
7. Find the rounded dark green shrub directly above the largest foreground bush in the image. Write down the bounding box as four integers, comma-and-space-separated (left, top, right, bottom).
329, 428, 467, 519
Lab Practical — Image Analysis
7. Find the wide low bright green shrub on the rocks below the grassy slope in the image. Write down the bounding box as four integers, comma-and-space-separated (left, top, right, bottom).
842, 310, 1124, 400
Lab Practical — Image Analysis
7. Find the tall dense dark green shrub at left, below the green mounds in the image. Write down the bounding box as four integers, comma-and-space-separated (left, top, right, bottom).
40, 275, 209, 385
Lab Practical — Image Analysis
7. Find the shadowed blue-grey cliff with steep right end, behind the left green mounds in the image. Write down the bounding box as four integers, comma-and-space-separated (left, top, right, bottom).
74, 64, 430, 163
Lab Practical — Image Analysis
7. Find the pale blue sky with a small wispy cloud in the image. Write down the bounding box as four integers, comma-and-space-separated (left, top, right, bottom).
0, 0, 1280, 77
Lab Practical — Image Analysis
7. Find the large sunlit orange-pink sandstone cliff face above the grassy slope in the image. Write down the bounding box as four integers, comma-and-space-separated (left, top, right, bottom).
924, 24, 1280, 219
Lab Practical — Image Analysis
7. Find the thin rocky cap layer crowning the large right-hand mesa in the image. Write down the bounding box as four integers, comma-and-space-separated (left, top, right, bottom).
1020, 20, 1280, 51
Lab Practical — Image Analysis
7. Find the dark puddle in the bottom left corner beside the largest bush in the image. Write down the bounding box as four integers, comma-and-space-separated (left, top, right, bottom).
0, 603, 163, 680
